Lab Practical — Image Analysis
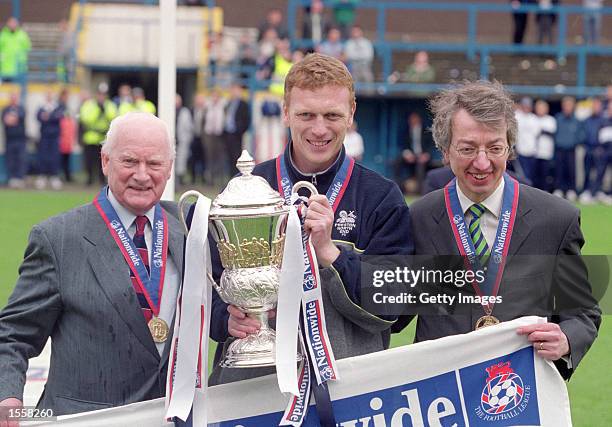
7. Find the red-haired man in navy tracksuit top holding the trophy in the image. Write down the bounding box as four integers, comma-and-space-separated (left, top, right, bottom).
209, 54, 413, 385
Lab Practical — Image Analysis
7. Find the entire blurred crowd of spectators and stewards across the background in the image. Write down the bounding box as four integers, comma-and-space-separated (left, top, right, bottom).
0, 0, 612, 203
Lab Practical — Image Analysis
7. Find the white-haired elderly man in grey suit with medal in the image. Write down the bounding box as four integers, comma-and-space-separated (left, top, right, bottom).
0, 113, 183, 423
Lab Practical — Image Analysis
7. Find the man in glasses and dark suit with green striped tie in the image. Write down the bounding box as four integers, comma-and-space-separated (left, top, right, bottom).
394, 82, 601, 378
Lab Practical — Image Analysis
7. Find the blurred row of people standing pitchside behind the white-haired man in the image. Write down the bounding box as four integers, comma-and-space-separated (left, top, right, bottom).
2, 83, 251, 190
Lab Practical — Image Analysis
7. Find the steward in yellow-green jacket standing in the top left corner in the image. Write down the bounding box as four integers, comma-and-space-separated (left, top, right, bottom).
0, 16, 32, 81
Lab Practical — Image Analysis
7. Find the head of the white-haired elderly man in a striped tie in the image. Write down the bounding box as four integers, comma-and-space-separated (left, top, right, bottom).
102, 120, 172, 215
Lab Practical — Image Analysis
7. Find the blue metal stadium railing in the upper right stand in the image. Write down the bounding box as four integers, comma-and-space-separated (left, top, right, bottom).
287, 0, 612, 96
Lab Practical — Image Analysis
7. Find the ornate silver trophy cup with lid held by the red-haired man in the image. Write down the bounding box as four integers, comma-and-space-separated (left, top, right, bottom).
179, 150, 301, 368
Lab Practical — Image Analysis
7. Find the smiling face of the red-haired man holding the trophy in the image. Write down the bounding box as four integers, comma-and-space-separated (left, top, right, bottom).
283, 85, 355, 173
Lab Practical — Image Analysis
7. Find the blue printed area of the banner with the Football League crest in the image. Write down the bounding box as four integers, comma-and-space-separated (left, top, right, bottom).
214, 347, 541, 427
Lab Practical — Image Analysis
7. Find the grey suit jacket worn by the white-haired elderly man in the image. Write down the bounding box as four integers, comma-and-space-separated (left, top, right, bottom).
0, 202, 184, 415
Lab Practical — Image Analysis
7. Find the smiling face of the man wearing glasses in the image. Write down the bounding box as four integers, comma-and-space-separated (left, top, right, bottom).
444, 109, 509, 203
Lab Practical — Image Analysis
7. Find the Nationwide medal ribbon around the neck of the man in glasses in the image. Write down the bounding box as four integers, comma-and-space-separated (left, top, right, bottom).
444, 173, 519, 316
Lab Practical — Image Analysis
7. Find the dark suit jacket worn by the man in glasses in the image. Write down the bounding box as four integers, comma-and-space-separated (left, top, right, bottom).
394, 184, 601, 378
